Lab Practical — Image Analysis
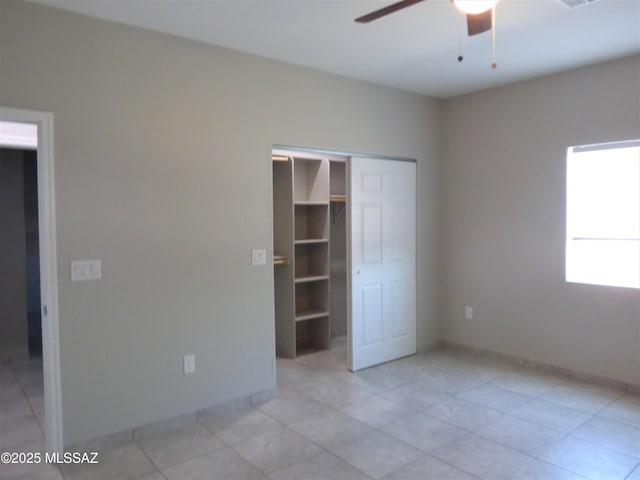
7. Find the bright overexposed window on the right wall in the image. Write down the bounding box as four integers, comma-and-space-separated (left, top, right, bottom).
566, 140, 640, 288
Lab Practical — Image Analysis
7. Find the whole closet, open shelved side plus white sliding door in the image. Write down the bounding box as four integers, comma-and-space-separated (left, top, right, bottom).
272, 147, 417, 372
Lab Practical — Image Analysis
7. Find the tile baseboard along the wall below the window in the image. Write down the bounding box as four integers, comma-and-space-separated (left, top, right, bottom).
438, 340, 640, 395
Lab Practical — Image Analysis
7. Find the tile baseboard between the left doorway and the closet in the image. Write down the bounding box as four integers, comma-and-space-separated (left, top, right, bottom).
65, 388, 278, 452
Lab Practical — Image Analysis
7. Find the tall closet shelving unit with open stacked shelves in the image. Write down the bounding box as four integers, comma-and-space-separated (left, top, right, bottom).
272, 152, 331, 358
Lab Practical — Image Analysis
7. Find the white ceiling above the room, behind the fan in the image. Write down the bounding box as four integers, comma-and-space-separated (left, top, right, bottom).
28, 0, 640, 98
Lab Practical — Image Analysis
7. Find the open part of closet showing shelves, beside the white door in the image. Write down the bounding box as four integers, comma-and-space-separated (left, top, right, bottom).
272, 149, 348, 370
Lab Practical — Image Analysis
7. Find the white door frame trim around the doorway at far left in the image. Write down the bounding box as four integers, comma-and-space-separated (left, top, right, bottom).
0, 107, 64, 453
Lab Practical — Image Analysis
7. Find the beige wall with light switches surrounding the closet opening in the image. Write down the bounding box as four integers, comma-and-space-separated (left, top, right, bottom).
0, 1, 441, 445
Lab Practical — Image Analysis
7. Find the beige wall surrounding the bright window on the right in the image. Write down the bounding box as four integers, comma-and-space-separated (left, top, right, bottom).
441, 57, 640, 384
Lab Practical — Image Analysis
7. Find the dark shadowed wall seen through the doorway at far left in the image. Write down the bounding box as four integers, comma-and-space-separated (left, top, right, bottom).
0, 149, 28, 361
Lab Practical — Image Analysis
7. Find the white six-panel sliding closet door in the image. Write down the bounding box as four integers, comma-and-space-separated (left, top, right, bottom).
349, 158, 416, 371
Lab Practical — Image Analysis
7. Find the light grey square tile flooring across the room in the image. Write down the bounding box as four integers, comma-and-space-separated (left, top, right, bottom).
0, 339, 640, 480
